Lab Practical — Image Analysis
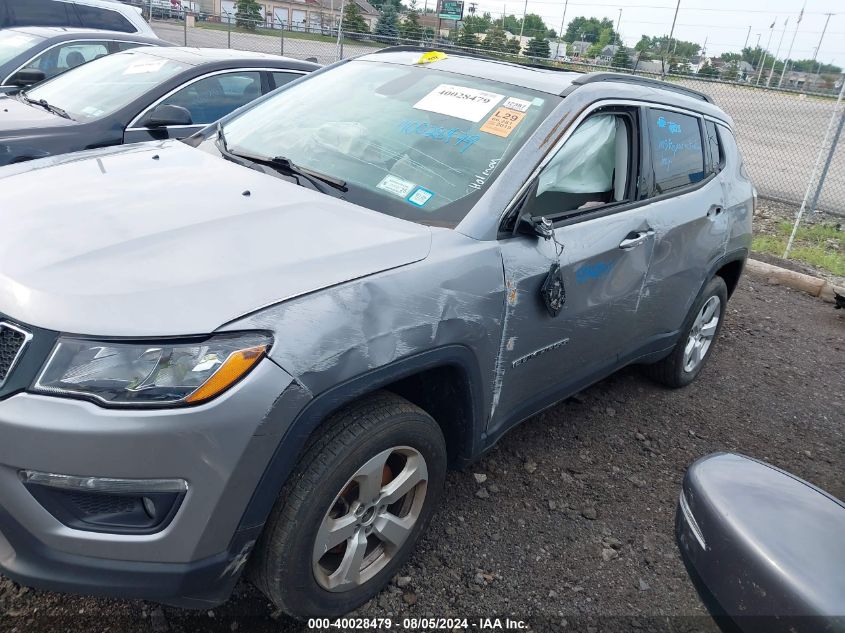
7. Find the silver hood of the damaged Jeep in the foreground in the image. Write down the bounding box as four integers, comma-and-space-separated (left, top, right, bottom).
0, 141, 431, 336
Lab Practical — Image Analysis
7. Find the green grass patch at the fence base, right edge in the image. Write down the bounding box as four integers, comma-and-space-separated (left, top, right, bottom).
751, 221, 845, 277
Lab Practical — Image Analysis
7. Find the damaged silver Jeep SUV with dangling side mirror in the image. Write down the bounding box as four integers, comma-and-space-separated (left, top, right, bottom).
0, 48, 754, 617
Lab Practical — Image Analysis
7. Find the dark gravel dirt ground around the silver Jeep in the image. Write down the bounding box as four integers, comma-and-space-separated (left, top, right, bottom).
0, 276, 845, 633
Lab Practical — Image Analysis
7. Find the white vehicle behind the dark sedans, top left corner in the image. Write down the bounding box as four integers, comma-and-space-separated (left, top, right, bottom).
0, 0, 155, 37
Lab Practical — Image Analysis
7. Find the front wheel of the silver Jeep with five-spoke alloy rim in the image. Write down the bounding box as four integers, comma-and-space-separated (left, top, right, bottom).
251, 392, 447, 619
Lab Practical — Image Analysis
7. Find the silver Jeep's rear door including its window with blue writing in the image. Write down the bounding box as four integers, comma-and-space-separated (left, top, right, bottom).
641, 106, 728, 347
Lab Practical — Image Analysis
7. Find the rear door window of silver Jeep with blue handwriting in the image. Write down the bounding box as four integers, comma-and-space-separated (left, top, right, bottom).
647, 109, 705, 194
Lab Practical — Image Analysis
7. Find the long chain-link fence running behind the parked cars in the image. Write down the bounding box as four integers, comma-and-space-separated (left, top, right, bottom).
152, 15, 845, 214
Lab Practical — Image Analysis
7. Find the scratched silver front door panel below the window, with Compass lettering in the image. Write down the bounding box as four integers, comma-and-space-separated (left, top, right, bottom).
491, 209, 654, 429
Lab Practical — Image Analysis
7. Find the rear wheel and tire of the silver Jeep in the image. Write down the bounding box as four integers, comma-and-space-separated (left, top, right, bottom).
646, 276, 728, 389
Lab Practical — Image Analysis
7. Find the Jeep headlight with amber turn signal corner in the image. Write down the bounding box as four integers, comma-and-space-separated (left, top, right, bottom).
33, 332, 272, 407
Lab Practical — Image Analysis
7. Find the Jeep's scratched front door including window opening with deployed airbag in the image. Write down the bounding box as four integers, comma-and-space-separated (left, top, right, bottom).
490, 108, 655, 432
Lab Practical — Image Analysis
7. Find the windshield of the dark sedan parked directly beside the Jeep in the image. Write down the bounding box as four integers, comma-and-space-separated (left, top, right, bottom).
26, 50, 188, 121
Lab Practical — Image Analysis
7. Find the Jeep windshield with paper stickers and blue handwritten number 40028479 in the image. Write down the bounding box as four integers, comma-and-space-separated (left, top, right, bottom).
223, 61, 559, 226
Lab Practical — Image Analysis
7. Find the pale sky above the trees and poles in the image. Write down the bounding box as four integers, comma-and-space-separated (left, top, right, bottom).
464, 0, 845, 66
